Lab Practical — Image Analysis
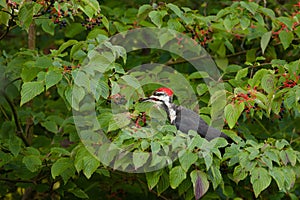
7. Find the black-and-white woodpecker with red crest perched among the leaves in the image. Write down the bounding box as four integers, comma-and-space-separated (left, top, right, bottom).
141, 87, 231, 142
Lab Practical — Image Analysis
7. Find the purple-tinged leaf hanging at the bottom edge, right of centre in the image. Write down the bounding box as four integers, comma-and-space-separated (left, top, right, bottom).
190, 170, 209, 199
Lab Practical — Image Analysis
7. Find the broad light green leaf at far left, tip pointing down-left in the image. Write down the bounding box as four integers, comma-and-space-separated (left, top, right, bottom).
20, 81, 44, 106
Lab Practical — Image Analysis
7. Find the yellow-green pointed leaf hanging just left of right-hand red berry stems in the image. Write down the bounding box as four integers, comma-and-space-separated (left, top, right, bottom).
224, 102, 245, 129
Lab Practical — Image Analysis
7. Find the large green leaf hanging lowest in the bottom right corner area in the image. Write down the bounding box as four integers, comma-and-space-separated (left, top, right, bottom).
250, 167, 272, 198
